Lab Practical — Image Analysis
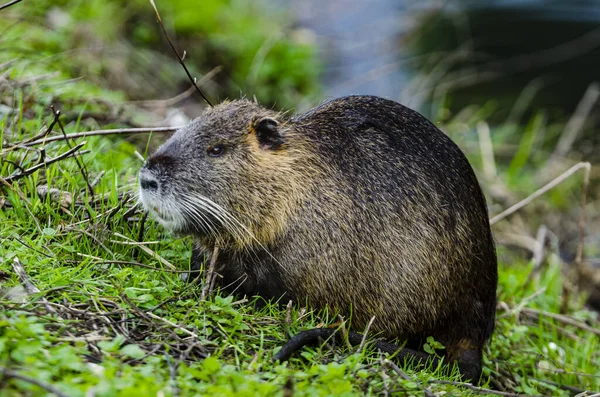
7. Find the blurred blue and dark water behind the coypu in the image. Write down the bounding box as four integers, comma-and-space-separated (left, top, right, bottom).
279, 0, 600, 124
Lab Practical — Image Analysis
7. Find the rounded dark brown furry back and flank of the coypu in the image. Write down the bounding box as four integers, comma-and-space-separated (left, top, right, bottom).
282, 96, 497, 352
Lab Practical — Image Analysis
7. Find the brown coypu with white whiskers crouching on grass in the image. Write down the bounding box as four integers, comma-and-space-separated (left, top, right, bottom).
139, 96, 497, 381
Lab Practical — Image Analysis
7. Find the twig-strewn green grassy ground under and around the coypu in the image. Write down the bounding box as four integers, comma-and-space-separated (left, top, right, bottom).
0, 1, 600, 396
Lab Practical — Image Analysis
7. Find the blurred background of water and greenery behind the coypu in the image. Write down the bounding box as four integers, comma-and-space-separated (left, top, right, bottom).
0, 0, 600, 306
